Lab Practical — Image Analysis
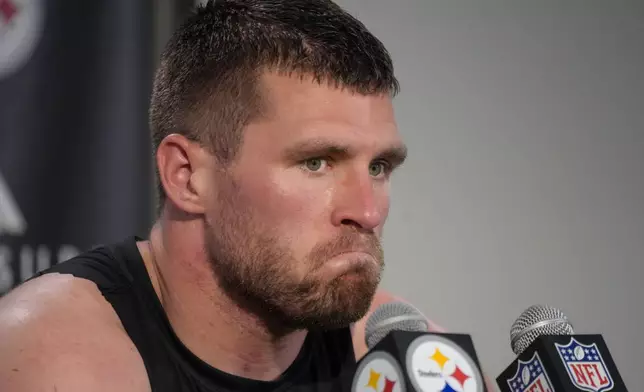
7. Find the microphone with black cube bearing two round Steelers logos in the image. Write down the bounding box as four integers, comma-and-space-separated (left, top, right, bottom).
349, 302, 487, 392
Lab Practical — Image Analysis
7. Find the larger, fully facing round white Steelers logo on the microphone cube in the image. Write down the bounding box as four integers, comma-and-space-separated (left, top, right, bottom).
406, 335, 483, 392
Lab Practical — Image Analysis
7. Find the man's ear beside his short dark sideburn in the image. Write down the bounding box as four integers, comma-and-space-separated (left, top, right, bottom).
156, 134, 209, 214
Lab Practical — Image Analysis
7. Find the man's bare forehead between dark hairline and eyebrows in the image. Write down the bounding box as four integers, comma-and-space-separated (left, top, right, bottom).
251, 73, 400, 145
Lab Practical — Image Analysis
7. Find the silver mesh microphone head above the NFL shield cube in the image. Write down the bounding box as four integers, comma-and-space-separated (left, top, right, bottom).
510, 305, 574, 355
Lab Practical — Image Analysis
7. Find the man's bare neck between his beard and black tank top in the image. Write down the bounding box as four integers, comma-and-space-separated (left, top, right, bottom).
139, 221, 306, 380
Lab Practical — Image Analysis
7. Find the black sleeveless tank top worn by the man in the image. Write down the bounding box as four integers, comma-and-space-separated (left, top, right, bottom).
34, 237, 356, 392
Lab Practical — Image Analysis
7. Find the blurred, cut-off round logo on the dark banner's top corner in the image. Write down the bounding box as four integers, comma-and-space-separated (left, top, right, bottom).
0, 0, 45, 79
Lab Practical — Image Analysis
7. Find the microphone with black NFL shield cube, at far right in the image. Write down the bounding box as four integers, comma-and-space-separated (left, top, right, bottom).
496, 305, 627, 392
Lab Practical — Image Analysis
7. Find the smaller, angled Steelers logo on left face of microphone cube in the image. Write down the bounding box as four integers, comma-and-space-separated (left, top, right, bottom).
351, 351, 405, 392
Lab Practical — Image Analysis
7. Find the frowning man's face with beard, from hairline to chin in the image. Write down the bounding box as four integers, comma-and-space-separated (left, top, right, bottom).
206, 74, 404, 328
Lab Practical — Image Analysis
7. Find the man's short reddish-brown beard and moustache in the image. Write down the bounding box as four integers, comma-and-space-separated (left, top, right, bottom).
205, 173, 384, 334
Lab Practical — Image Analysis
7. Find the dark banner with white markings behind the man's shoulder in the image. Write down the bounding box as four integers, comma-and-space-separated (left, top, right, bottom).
0, 0, 154, 295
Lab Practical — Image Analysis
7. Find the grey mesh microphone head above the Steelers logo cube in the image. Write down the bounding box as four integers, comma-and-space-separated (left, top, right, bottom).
365, 302, 429, 350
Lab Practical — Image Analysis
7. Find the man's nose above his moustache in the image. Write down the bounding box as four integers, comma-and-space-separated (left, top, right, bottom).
332, 176, 388, 231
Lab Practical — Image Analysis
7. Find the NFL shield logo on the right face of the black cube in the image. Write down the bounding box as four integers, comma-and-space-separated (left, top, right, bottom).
555, 338, 614, 392
